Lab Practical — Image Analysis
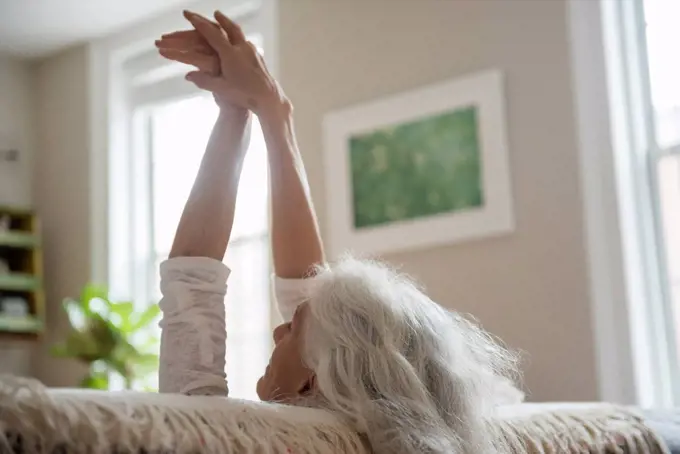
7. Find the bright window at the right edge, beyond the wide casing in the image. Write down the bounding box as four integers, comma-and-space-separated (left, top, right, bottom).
601, 0, 680, 406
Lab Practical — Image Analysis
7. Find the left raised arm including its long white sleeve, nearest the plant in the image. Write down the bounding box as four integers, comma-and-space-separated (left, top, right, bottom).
159, 10, 251, 395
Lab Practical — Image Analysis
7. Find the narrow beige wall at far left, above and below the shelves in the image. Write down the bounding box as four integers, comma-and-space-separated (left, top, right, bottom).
0, 58, 36, 375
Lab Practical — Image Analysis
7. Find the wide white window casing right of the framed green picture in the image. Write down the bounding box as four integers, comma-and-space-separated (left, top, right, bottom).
568, 0, 680, 407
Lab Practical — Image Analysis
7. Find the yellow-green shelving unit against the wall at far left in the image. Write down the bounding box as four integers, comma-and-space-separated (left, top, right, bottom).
0, 206, 45, 336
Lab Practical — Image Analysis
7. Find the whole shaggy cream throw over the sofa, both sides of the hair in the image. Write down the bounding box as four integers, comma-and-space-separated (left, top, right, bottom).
0, 376, 668, 454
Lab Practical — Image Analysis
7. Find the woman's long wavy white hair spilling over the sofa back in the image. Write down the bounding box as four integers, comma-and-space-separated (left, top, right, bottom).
303, 258, 523, 454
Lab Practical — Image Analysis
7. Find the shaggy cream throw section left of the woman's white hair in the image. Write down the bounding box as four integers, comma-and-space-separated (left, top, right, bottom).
0, 376, 368, 454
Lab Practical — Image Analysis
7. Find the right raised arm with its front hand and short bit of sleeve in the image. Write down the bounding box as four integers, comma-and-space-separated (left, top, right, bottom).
157, 9, 324, 326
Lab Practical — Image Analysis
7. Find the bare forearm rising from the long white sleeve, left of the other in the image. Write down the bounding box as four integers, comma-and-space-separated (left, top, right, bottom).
170, 111, 250, 260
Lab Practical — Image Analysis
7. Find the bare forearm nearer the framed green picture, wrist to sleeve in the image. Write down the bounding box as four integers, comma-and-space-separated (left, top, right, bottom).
259, 105, 324, 279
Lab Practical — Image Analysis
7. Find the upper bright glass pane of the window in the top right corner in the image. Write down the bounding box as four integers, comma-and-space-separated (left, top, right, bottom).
644, 0, 680, 148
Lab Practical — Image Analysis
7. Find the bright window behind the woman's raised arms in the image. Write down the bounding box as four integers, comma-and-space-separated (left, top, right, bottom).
109, 31, 271, 399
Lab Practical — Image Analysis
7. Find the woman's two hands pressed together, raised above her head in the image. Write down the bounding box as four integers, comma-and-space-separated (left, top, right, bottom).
156, 11, 286, 114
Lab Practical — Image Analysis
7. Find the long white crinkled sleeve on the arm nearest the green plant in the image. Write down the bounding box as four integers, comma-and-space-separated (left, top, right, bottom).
158, 257, 229, 395
